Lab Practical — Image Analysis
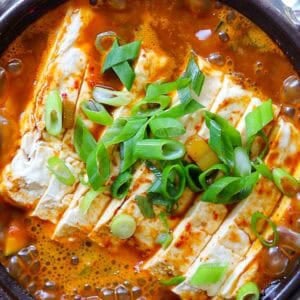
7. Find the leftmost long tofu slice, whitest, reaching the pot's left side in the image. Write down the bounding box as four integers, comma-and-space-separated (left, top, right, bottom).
0, 9, 88, 208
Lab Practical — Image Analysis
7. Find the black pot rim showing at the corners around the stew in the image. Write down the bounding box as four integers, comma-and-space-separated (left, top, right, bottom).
0, 0, 300, 300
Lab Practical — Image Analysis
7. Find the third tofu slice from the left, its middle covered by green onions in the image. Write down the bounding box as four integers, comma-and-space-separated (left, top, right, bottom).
53, 49, 169, 239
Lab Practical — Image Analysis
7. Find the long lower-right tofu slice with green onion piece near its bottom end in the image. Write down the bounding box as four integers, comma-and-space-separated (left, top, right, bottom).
174, 118, 300, 296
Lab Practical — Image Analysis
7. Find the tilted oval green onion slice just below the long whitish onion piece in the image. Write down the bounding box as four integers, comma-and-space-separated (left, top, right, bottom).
81, 100, 113, 126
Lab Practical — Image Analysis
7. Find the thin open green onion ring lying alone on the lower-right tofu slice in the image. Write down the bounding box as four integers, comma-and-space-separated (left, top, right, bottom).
251, 211, 279, 248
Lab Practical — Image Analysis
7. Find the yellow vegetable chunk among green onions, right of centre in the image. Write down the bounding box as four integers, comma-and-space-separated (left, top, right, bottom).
186, 135, 219, 171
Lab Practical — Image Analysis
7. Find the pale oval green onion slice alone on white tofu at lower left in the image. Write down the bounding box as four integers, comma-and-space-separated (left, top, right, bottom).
48, 156, 75, 186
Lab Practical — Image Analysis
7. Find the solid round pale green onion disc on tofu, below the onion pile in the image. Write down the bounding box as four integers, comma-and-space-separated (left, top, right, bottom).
110, 214, 136, 240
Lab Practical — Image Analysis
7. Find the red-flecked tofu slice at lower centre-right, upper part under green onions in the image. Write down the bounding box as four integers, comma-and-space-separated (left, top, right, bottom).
144, 97, 270, 278
